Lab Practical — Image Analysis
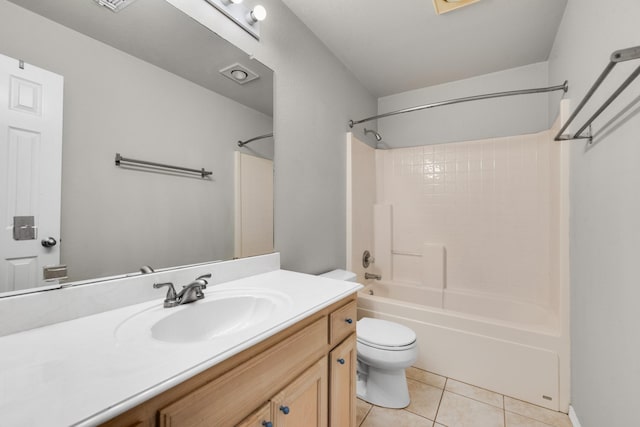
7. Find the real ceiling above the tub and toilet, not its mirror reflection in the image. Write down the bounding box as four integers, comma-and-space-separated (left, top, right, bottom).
283, 0, 567, 97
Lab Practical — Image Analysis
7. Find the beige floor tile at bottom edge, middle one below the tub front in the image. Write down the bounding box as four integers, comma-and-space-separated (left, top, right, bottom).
436, 391, 504, 427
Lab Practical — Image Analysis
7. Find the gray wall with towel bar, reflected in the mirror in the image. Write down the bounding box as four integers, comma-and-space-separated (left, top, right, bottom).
0, 0, 273, 280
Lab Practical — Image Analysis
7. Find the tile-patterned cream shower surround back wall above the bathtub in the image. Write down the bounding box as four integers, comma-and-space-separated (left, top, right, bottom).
374, 132, 559, 312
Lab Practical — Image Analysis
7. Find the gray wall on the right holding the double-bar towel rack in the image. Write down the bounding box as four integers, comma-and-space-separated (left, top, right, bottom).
549, 0, 640, 427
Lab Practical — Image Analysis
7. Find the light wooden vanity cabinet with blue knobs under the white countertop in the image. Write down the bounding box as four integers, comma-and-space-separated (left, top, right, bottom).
103, 295, 356, 427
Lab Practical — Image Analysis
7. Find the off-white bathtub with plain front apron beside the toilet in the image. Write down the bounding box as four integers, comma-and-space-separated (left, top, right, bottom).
358, 282, 569, 412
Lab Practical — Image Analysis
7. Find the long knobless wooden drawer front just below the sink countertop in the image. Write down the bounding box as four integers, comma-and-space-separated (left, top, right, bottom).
159, 316, 327, 427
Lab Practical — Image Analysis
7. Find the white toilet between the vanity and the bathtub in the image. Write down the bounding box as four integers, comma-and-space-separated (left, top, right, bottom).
321, 270, 418, 408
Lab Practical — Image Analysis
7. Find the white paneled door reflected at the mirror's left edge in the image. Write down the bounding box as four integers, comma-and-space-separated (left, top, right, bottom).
0, 55, 63, 292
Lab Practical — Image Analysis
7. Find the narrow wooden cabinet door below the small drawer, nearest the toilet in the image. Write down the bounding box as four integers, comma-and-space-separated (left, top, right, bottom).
329, 334, 357, 427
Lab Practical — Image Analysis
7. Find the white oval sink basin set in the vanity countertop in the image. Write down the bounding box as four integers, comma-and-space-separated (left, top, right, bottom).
116, 289, 290, 343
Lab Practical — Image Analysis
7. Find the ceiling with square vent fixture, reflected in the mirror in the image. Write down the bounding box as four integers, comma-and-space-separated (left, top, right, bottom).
9, 0, 273, 116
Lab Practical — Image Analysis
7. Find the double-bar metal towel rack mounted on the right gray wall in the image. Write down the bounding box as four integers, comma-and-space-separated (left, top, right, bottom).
554, 46, 640, 143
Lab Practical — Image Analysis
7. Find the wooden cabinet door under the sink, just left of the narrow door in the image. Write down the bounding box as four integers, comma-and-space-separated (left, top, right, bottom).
271, 357, 327, 427
